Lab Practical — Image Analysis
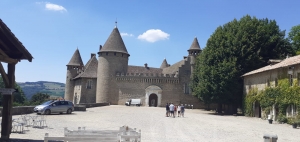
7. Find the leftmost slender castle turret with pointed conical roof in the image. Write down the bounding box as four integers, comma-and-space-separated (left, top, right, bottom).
65, 49, 83, 101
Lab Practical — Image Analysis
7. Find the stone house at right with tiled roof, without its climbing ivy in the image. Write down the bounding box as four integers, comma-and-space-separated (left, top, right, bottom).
242, 55, 300, 120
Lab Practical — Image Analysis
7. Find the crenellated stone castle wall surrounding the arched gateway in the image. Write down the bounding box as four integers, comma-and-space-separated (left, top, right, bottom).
116, 77, 182, 106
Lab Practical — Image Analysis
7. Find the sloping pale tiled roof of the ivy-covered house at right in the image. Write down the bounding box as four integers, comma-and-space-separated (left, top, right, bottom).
242, 55, 300, 77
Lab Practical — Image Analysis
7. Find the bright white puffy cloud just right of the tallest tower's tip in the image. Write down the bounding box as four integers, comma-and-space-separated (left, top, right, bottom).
138, 29, 170, 42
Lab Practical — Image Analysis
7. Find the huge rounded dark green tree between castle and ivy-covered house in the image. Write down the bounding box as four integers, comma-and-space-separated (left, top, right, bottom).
192, 15, 294, 111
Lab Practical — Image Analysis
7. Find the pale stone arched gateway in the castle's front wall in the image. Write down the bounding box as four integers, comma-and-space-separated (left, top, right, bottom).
145, 85, 162, 107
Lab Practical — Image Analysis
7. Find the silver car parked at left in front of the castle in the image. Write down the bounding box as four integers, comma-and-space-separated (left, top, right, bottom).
33, 101, 74, 114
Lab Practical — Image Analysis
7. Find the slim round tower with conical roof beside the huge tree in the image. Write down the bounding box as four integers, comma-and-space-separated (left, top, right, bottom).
188, 37, 202, 75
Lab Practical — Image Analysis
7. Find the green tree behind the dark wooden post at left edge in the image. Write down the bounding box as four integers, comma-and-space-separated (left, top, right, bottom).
0, 76, 26, 106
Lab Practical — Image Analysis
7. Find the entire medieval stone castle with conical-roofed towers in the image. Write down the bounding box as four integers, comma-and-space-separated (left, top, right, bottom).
65, 27, 204, 108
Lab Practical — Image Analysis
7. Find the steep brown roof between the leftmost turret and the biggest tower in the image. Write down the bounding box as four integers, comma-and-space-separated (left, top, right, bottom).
74, 55, 98, 79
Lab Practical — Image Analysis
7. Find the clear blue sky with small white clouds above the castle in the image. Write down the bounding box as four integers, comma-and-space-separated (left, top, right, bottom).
0, 0, 300, 83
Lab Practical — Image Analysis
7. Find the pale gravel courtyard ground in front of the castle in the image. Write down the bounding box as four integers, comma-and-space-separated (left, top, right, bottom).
3, 106, 300, 142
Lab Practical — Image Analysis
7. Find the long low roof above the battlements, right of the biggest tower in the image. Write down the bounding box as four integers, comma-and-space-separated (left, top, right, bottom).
127, 65, 162, 74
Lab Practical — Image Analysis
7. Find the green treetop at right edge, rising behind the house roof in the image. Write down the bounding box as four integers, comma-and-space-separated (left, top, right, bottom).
288, 25, 300, 55
